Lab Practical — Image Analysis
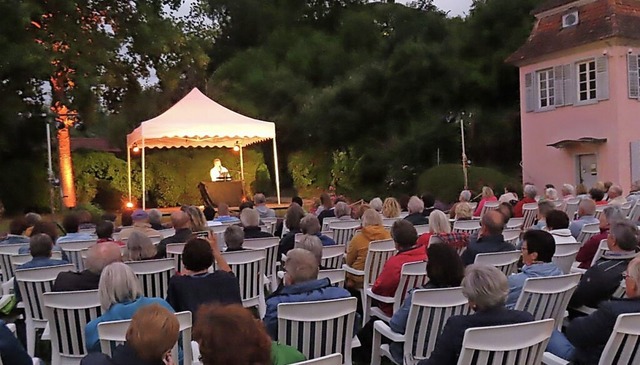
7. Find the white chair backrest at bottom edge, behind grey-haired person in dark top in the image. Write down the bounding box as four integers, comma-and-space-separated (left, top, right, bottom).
458, 319, 554, 365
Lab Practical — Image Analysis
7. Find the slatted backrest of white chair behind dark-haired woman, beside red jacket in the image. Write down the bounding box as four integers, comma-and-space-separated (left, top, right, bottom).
404, 287, 471, 360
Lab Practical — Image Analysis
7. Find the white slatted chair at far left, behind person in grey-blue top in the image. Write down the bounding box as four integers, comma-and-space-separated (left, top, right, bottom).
15, 264, 75, 357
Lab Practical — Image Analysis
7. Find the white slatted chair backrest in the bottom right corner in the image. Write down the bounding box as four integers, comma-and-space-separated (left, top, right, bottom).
598, 313, 640, 365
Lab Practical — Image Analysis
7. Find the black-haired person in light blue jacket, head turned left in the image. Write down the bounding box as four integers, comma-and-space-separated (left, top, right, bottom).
506, 229, 563, 308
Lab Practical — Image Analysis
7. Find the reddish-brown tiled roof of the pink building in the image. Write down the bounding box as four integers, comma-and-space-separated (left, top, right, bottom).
506, 0, 640, 64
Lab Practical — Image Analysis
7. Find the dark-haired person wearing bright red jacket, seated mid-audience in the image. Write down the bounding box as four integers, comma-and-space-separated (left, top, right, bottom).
371, 219, 427, 317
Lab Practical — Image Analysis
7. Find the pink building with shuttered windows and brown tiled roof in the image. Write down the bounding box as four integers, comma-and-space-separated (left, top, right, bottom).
507, 0, 640, 192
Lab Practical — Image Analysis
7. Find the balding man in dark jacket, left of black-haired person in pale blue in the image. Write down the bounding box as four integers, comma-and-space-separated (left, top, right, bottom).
461, 211, 516, 265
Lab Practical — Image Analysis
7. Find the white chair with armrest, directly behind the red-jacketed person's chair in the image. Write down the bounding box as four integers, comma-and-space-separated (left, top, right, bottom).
371, 287, 471, 365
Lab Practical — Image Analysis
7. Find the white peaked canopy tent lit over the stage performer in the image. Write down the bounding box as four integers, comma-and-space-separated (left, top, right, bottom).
127, 88, 280, 209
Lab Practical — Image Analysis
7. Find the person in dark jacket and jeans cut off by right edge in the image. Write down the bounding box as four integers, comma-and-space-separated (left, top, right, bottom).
547, 252, 640, 364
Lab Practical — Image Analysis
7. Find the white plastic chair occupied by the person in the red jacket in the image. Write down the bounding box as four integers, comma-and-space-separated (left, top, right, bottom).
362, 261, 429, 323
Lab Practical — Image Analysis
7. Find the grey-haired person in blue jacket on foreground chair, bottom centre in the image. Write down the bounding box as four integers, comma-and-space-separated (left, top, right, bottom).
263, 247, 350, 340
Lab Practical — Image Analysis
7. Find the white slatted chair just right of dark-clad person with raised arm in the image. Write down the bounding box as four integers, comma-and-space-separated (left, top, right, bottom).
222, 250, 268, 318
